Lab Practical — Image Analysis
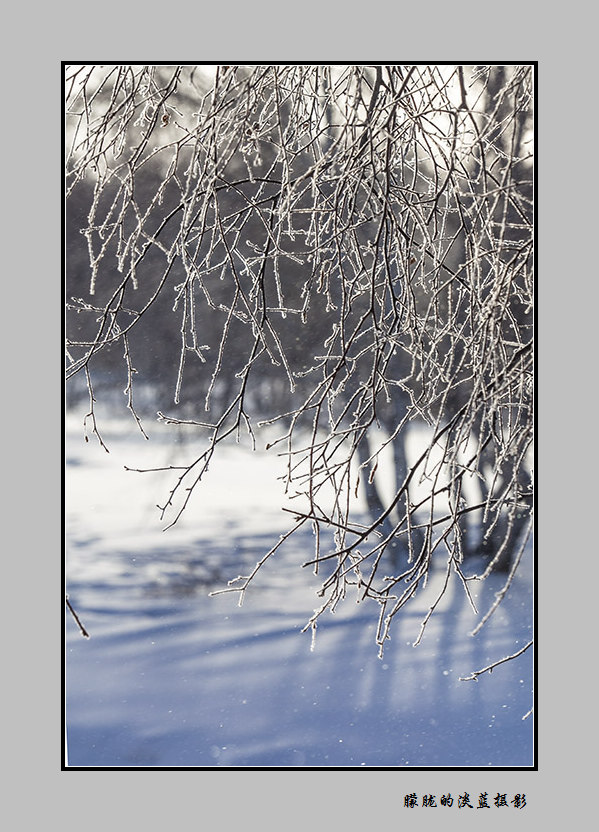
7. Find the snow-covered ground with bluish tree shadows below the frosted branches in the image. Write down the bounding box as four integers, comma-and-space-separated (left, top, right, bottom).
65, 415, 534, 768
